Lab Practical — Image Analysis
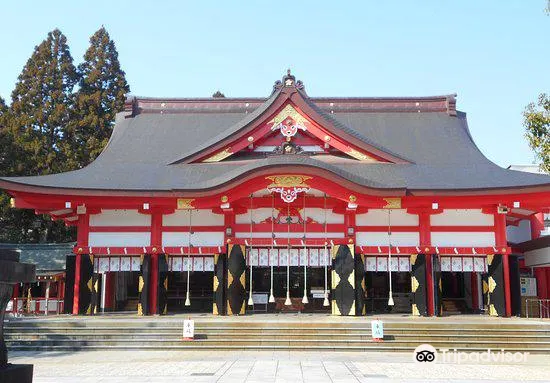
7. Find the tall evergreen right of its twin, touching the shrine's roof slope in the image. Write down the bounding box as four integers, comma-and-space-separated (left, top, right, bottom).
73, 27, 130, 167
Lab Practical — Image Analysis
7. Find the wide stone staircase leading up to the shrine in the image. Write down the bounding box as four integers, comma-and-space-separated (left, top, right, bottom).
5, 317, 550, 354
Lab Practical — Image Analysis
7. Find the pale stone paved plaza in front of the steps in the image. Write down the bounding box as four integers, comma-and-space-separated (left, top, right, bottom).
10, 351, 550, 383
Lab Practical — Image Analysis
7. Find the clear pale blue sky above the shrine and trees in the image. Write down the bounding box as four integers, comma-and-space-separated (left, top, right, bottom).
0, 0, 550, 166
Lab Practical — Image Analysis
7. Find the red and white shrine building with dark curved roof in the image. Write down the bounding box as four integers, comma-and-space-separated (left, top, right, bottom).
0, 71, 550, 316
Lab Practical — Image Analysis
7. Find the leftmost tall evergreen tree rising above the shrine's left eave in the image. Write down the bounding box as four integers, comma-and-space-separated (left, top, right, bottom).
10, 29, 78, 175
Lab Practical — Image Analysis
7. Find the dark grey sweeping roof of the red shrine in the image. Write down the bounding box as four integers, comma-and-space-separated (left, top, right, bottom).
0, 88, 550, 191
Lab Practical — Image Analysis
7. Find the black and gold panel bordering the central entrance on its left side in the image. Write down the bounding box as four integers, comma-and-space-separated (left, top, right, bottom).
227, 245, 246, 315
